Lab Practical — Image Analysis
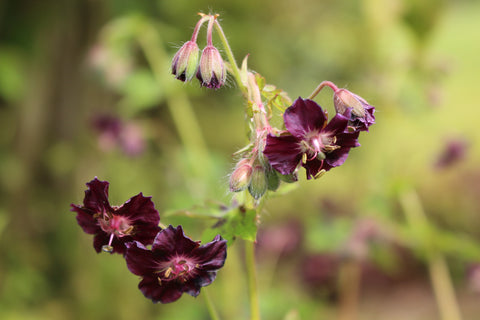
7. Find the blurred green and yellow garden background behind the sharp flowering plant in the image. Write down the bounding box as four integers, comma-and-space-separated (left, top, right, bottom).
0, 0, 480, 320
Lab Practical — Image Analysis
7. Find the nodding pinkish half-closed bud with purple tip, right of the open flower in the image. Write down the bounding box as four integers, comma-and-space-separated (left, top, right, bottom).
333, 89, 375, 131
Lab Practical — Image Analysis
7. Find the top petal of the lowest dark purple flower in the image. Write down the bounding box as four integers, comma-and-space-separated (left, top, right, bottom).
152, 225, 199, 256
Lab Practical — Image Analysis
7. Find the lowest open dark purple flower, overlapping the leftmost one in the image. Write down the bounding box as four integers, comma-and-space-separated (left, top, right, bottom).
125, 226, 227, 303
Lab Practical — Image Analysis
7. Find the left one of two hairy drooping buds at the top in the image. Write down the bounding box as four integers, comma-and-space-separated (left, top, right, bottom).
172, 41, 200, 81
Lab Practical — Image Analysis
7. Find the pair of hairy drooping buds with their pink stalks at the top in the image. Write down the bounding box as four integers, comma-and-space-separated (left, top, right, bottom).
172, 14, 227, 89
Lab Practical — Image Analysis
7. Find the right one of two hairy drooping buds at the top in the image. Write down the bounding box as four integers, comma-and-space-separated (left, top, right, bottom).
197, 45, 227, 89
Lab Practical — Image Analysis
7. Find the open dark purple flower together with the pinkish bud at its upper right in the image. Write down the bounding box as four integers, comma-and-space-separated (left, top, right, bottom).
263, 82, 375, 179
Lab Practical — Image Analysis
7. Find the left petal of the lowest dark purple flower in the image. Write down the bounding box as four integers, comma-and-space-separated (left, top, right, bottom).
125, 241, 160, 276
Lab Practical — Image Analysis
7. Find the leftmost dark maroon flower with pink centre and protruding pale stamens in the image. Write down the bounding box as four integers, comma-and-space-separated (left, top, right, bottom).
71, 178, 160, 254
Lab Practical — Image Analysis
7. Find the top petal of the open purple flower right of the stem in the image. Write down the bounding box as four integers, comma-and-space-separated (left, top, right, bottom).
283, 98, 327, 138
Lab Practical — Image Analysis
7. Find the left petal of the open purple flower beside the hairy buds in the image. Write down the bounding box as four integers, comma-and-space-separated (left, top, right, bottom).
263, 134, 302, 175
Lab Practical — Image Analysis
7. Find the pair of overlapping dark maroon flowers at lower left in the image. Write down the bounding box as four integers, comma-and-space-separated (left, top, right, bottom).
71, 178, 227, 303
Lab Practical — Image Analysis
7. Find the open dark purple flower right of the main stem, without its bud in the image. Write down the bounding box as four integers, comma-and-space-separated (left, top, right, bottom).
263, 98, 360, 179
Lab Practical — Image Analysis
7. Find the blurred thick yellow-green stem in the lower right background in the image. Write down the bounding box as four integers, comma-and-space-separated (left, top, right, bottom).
400, 190, 462, 320
